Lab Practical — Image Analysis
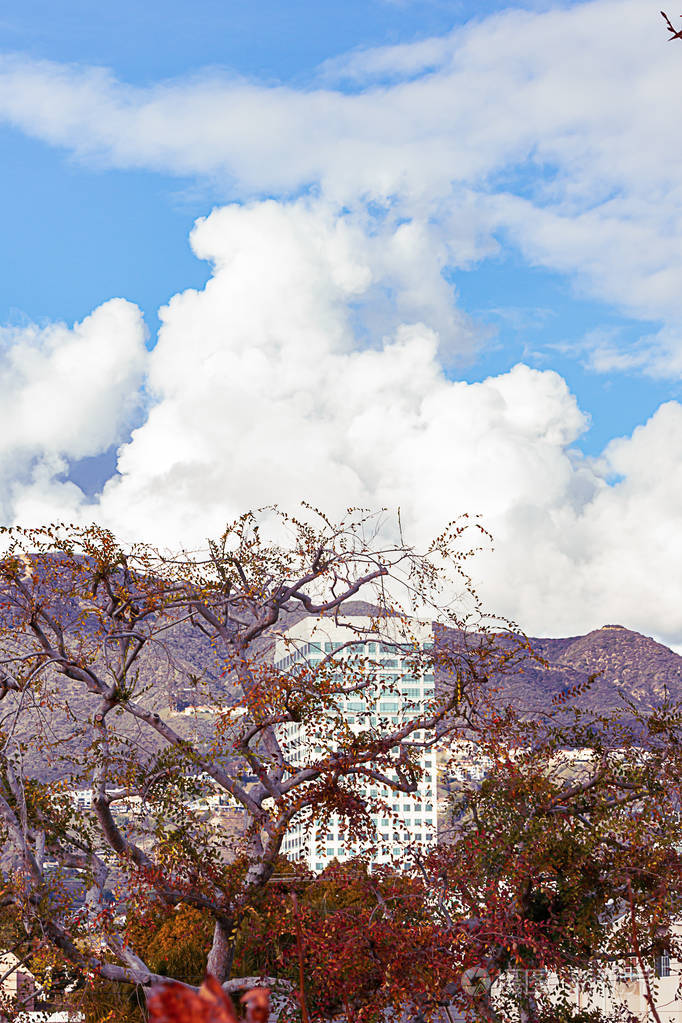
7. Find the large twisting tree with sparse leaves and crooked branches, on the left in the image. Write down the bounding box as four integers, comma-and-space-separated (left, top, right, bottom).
0, 512, 511, 1014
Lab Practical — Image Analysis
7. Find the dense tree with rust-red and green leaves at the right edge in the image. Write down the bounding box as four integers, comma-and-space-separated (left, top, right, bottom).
413, 695, 682, 1023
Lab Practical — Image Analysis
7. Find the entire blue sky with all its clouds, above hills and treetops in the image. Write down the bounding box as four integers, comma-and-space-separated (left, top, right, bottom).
0, 0, 682, 641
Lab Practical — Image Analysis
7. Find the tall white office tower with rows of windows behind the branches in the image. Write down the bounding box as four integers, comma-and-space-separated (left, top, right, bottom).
275, 618, 438, 873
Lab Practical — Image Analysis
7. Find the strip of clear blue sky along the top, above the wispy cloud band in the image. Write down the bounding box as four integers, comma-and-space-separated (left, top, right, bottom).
2, 0, 556, 83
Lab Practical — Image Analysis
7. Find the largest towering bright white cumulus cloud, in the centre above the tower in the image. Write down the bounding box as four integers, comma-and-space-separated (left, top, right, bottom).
92, 194, 585, 542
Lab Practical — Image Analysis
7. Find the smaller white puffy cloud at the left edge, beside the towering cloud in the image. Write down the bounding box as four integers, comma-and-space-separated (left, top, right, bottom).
0, 299, 146, 522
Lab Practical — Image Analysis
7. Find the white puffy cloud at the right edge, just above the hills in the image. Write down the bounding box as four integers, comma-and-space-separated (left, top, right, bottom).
480, 402, 682, 646
